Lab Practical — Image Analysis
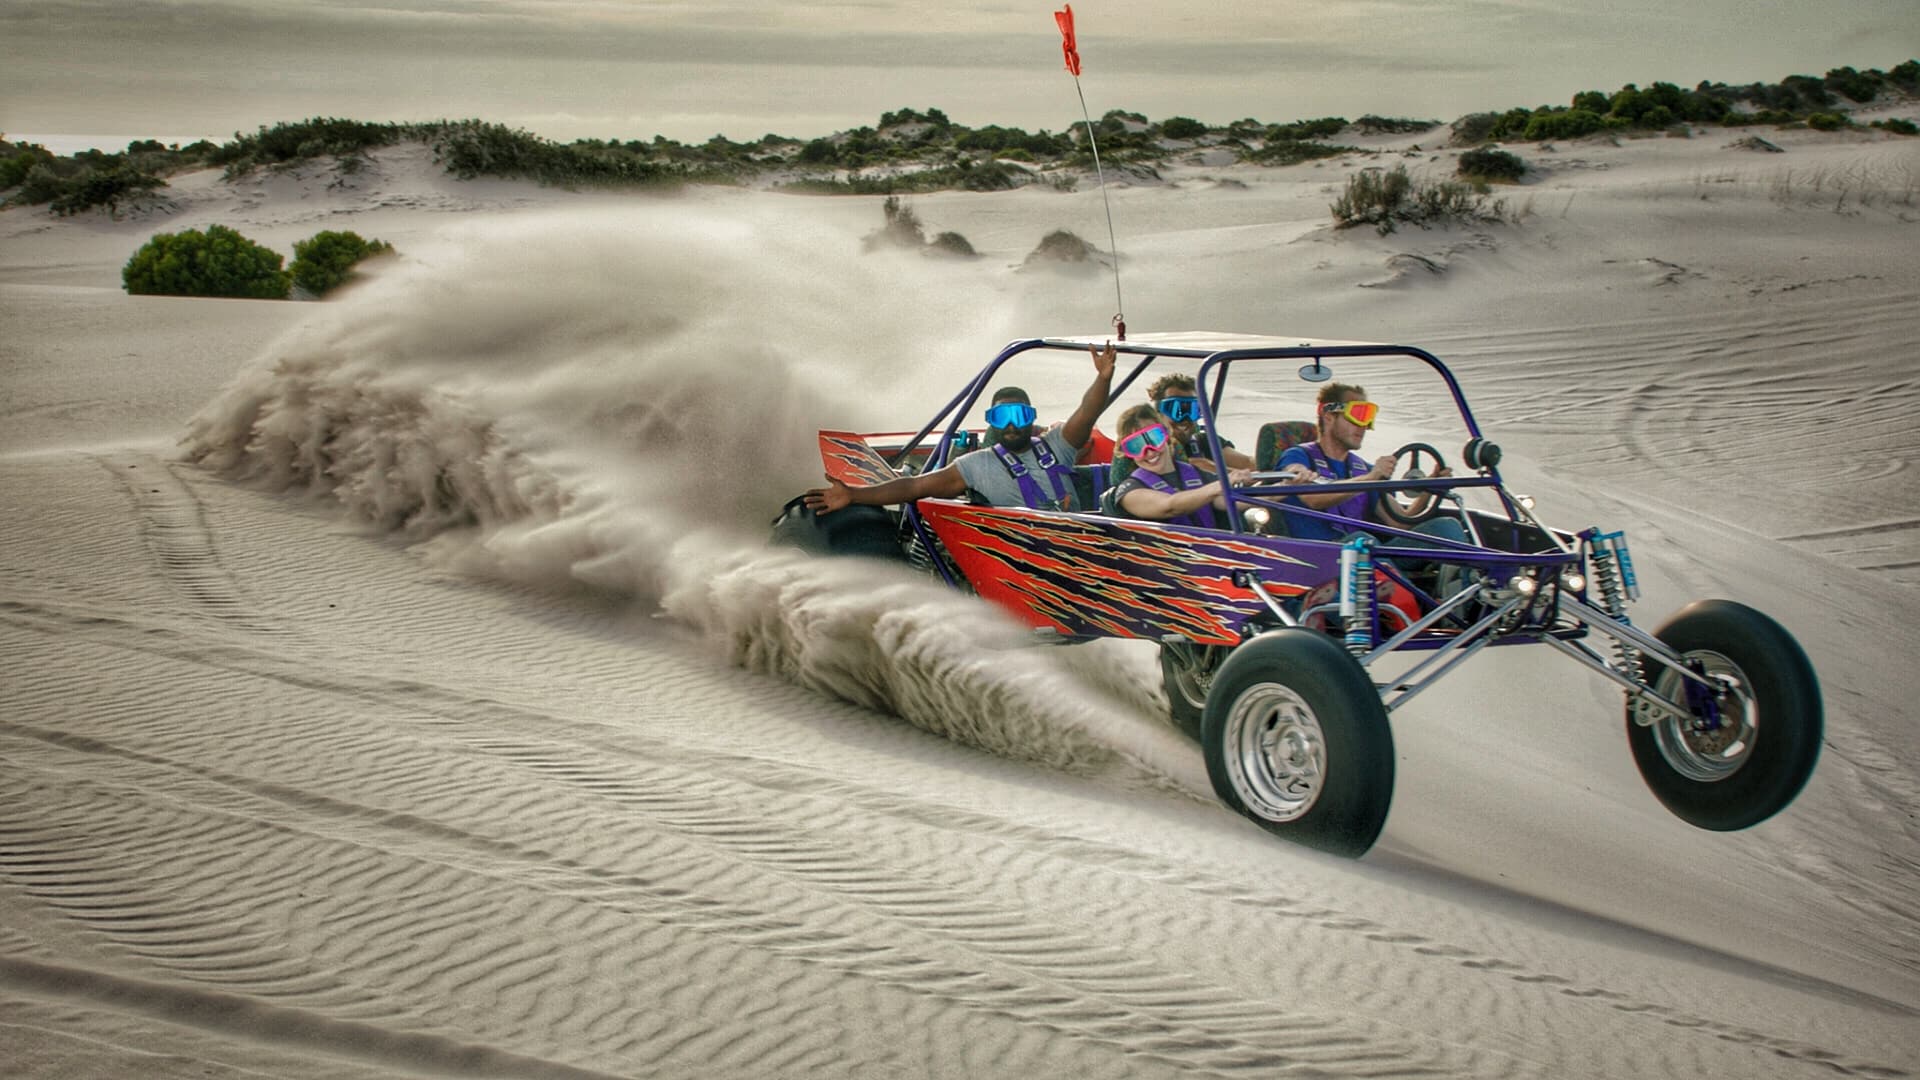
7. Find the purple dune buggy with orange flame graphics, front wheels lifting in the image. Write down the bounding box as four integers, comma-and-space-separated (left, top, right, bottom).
774, 332, 1824, 857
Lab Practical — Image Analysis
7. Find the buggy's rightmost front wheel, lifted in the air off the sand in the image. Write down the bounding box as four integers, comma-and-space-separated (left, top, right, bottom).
1626, 600, 1826, 832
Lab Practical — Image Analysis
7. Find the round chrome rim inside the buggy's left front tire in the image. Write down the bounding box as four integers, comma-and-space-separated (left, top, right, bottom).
1223, 682, 1327, 822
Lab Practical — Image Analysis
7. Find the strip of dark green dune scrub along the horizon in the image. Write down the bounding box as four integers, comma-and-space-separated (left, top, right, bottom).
0, 60, 1920, 215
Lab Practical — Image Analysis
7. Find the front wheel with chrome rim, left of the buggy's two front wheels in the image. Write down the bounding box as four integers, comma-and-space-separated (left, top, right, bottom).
1200, 626, 1394, 859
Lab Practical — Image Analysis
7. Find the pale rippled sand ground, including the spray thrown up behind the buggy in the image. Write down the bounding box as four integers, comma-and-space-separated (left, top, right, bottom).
0, 122, 1920, 1078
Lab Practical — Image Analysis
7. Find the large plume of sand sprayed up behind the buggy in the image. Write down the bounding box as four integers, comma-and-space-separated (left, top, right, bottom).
184, 208, 1204, 790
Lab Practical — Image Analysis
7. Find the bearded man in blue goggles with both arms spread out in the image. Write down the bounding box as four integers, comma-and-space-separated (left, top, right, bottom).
803, 342, 1116, 513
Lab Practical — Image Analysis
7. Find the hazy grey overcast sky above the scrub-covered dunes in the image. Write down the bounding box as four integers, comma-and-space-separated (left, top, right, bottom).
0, 0, 1920, 150
